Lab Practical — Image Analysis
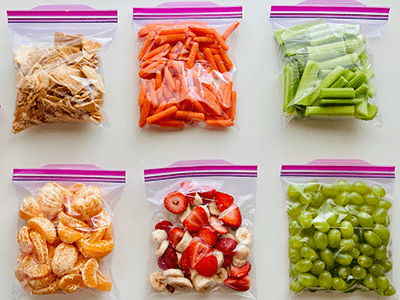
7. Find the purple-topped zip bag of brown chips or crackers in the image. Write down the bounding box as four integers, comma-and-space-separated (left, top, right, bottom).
7, 5, 118, 133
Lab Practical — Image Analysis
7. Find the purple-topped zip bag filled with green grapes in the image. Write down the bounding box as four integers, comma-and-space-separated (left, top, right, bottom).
281, 160, 397, 299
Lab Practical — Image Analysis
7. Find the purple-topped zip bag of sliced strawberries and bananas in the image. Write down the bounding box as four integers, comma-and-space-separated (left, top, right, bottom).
144, 160, 257, 299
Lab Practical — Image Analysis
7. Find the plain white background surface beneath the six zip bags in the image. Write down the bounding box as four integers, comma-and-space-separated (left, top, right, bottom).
0, 0, 400, 300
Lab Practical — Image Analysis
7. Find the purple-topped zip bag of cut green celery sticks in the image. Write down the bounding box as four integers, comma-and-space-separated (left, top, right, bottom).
270, 0, 390, 127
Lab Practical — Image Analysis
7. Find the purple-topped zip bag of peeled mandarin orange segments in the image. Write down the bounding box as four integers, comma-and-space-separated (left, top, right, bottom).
11, 165, 125, 300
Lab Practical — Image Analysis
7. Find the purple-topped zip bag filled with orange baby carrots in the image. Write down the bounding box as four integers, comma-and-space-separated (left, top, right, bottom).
133, 2, 242, 128
